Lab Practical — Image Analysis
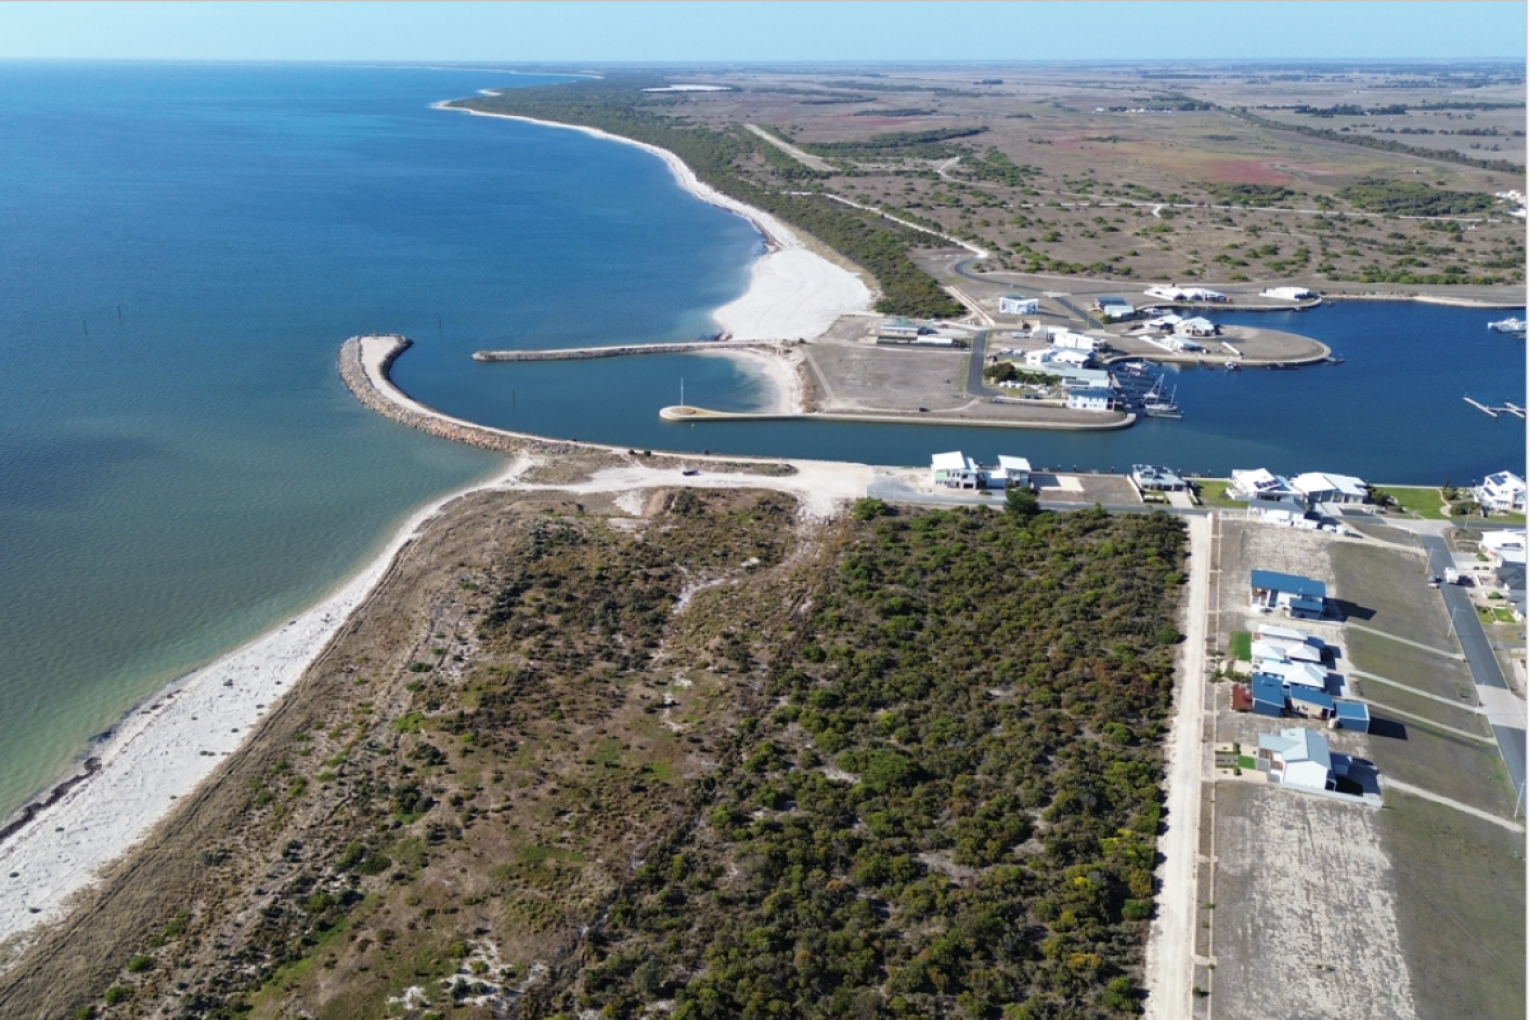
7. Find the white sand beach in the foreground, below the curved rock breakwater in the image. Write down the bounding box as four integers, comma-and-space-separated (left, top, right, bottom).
0, 459, 529, 942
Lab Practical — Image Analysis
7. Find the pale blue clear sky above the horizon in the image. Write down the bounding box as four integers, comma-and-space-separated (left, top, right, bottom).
0, 0, 1525, 63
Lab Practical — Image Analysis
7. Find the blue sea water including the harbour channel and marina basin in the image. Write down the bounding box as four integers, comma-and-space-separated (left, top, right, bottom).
0, 63, 1525, 815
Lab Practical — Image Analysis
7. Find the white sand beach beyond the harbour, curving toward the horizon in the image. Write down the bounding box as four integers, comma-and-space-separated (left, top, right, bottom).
433, 102, 875, 339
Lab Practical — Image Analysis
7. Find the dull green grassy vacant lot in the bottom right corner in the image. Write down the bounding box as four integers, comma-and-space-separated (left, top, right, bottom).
1380, 792, 1525, 1020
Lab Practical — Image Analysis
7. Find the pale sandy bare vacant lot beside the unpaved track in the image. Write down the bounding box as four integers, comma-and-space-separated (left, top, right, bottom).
1209, 783, 1418, 1020
